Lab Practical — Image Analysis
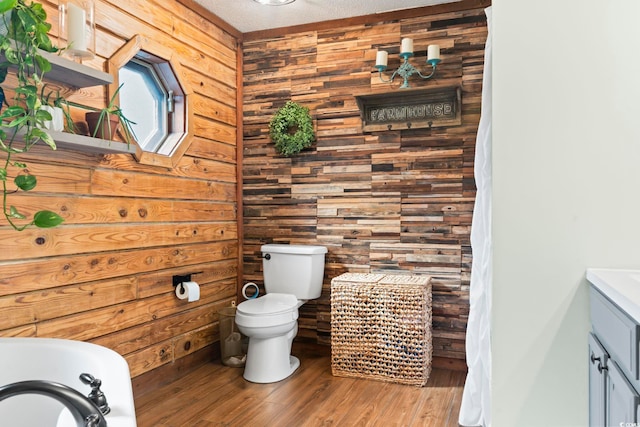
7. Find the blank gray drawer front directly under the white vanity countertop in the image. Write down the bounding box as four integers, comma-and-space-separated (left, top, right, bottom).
591, 287, 640, 381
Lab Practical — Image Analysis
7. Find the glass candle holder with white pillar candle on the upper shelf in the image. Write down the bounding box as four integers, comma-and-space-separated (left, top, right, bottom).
58, 0, 96, 62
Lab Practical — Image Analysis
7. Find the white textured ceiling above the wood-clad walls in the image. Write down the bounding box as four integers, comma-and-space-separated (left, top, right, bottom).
195, 0, 457, 33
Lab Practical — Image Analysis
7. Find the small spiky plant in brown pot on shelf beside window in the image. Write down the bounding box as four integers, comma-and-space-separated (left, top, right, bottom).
85, 83, 136, 145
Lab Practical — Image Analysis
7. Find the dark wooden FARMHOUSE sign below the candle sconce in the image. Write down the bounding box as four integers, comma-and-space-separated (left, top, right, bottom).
356, 86, 462, 132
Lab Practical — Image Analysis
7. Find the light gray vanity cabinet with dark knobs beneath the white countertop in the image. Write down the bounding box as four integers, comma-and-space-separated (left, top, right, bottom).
587, 275, 640, 427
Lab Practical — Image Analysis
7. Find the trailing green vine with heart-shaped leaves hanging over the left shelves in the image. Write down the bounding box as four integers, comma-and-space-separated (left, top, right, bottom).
0, 0, 63, 230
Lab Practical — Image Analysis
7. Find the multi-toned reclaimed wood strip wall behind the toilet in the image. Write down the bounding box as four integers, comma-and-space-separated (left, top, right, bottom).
242, 6, 487, 359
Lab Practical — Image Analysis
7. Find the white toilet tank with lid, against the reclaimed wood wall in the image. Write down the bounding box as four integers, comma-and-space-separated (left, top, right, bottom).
260, 244, 327, 300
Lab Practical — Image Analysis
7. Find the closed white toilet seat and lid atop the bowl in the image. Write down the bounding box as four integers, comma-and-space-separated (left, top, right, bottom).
236, 293, 299, 328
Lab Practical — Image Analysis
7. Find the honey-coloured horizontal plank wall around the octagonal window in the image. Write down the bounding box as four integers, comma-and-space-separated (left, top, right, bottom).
0, 0, 239, 377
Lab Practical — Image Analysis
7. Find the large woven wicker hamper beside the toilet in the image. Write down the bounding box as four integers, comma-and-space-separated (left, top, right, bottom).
331, 273, 432, 386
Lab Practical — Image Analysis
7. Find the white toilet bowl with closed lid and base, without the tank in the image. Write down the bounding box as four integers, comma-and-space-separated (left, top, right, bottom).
236, 293, 302, 383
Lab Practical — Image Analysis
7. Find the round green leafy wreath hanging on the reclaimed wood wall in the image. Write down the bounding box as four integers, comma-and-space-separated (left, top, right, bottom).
269, 101, 316, 157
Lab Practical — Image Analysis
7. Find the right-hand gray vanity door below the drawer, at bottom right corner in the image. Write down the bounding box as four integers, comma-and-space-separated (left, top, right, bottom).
606, 359, 640, 427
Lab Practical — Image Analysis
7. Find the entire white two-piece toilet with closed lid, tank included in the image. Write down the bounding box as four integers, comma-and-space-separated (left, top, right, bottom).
236, 244, 327, 383
